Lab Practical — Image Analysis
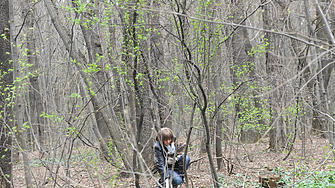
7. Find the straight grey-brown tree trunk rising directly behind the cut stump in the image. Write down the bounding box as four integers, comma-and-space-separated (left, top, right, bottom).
263, 1, 286, 149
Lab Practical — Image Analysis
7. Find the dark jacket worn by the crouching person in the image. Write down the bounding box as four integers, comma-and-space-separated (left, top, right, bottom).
155, 135, 177, 179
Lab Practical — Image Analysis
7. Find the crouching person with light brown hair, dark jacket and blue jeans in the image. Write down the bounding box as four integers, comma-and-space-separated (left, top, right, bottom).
155, 127, 190, 187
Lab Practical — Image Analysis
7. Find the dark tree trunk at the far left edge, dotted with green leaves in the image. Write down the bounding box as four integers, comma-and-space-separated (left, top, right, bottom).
0, 0, 14, 188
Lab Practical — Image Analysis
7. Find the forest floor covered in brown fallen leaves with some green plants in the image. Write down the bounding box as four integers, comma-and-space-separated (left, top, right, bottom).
13, 136, 334, 188
